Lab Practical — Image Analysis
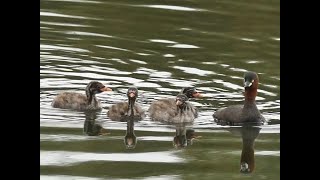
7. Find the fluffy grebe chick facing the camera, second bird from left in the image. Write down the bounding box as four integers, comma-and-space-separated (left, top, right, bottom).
107, 87, 145, 121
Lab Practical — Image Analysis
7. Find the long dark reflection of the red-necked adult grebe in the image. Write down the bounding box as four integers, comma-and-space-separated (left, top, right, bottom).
228, 124, 261, 173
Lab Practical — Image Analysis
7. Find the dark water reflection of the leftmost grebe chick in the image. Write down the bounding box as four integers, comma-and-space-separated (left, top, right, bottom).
83, 111, 110, 136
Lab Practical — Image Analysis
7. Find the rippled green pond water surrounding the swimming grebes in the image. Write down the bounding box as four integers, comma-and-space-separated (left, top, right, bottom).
40, 0, 280, 180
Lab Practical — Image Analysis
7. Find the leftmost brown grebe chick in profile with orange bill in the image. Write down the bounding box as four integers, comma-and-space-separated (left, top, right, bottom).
51, 81, 112, 111
